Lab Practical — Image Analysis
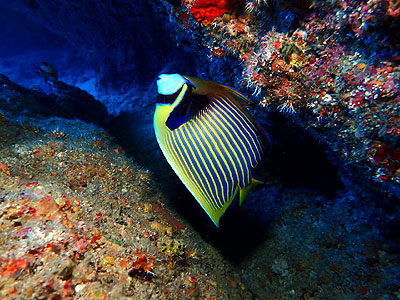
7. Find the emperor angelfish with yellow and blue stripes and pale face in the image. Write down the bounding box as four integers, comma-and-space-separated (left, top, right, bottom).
154, 74, 269, 226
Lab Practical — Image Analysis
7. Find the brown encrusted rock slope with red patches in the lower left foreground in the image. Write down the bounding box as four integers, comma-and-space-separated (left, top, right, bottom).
0, 103, 251, 300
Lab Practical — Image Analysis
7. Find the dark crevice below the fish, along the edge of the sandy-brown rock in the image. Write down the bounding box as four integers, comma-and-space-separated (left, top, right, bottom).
106, 113, 271, 262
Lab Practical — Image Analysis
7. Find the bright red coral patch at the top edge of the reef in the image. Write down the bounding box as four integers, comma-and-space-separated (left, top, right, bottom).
189, 0, 230, 22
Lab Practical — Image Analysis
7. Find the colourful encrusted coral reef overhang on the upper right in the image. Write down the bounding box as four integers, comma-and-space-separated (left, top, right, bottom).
169, 1, 400, 190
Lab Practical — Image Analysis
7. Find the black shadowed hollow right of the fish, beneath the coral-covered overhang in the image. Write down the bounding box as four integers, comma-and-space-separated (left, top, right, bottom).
262, 113, 343, 198
